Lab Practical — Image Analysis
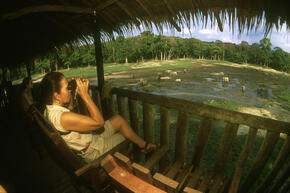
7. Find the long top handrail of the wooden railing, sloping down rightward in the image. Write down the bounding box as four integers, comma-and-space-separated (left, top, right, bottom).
112, 88, 290, 134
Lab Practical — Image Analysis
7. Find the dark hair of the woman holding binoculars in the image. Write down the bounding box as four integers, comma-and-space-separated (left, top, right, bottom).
40, 72, 64, 107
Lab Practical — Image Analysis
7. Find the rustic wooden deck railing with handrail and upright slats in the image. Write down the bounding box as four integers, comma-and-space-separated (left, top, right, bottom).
91, 87, 290, 193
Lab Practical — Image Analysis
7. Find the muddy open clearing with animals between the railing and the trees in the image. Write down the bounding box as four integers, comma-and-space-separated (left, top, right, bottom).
90, 60, 290, 122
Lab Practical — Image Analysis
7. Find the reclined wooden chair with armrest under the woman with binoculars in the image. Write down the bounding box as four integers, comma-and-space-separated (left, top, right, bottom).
31, 106, 129, 192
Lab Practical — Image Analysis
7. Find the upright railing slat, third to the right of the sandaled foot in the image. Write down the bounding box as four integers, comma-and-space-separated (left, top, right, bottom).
192, 117, 214, 168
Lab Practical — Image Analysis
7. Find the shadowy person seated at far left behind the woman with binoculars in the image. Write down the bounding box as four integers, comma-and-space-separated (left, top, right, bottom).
20, 77, 33, 113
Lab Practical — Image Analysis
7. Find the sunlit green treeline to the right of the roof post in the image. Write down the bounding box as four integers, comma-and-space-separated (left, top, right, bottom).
103, 31, 290, 72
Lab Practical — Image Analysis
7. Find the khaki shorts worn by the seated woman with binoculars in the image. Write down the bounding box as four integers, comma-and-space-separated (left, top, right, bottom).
80, 120, 125, 162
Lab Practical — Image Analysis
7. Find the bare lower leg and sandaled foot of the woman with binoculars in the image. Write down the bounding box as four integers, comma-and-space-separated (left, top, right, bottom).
110, 115, 157, 149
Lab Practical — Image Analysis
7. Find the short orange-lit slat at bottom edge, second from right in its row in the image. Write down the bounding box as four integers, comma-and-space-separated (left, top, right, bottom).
153, 173, 179, 193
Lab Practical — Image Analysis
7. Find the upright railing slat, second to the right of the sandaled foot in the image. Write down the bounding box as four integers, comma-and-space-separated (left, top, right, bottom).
175, 111, 189, 162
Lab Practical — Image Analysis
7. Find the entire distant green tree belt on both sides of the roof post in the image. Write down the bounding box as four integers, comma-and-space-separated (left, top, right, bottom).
0, 31, 290, 83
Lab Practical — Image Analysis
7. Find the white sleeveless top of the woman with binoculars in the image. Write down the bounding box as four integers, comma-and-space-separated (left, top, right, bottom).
44, 105, 92, 151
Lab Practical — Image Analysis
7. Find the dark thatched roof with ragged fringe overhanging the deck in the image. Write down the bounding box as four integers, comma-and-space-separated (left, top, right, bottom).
0, 0, 290, 66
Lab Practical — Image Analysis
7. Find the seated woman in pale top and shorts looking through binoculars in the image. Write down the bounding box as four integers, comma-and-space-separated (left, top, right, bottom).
42, 72, 157, 162
